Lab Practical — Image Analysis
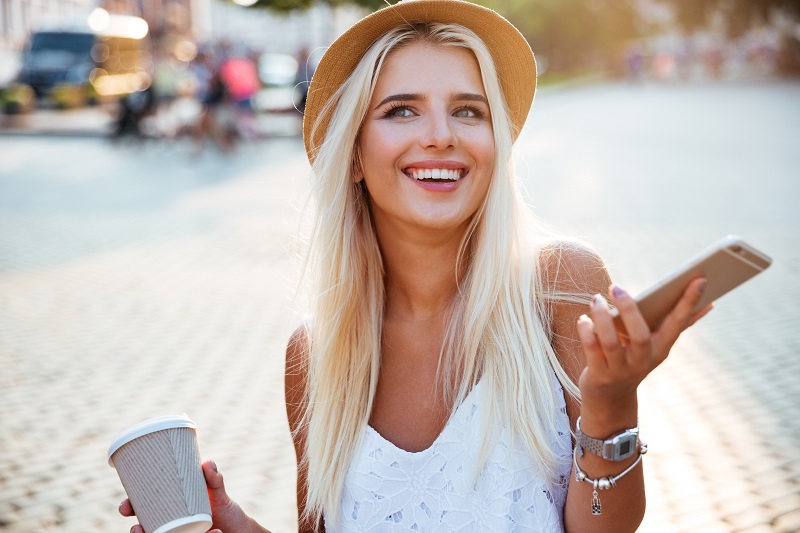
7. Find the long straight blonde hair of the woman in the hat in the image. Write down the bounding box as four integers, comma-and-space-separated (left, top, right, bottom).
298, 23, 577, 524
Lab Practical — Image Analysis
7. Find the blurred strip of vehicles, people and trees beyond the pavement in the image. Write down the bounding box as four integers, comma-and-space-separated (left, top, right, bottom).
0, 0, 800, 137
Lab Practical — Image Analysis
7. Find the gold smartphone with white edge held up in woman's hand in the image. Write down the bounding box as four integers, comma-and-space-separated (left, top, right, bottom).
611, 235, 772, 331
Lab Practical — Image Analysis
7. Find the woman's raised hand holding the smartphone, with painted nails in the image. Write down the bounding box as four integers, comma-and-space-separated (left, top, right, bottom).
578, 278, 712, 418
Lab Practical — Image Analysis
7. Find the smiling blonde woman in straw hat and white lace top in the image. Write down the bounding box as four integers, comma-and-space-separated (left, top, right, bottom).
117, 0, 707, 533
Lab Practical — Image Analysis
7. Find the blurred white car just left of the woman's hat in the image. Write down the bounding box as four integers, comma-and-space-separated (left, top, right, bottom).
254, 53, 302, 113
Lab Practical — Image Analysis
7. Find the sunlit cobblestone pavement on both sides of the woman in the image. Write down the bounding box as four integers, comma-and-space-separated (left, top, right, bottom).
0, 84, 800, 533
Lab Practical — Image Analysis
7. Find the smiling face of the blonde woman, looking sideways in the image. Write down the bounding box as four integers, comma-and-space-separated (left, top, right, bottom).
357, 42, 495, 239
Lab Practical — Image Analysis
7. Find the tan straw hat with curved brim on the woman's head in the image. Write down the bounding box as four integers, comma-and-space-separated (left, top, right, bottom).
303, 0, 536, 161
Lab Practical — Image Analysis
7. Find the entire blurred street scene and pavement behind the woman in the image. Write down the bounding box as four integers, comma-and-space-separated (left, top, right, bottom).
0, 0, 800, 533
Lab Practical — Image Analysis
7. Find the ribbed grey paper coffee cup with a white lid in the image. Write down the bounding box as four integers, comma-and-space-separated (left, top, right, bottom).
108, 415, 212, 533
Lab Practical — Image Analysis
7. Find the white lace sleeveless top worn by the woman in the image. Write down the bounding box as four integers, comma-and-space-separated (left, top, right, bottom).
325, 375, 571, 533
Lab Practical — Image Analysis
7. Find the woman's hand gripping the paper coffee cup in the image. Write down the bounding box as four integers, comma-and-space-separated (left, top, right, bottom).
119, 461, 266, 533
